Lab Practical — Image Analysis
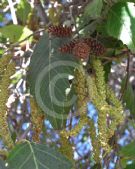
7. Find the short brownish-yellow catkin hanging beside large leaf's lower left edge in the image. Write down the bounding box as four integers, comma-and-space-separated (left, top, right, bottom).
30, 98, 45, 142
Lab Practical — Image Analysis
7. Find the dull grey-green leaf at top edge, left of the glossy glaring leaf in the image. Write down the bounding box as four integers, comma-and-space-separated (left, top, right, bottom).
84, 0, 103, 18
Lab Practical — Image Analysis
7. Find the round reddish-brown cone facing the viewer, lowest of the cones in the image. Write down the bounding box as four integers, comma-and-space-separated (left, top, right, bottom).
73, 42, 90, 59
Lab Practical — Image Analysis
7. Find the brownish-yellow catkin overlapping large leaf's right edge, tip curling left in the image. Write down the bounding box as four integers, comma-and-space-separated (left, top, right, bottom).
61, 64, 88, 137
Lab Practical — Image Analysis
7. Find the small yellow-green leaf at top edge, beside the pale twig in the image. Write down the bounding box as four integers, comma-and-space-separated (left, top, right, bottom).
16, 0, 31, 24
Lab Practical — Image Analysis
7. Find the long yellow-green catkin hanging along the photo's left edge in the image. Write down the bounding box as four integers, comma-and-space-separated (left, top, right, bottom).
0, 59, 15, 148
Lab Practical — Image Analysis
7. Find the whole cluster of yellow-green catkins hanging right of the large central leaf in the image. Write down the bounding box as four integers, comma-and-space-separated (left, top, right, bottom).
87, 60, 123, 152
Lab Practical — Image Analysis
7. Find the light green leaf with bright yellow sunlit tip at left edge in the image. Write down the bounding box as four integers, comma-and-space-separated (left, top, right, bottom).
0, 25, 32, 42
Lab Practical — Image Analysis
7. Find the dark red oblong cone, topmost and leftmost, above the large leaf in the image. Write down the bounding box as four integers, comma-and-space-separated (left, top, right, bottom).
48, 25, 72, 37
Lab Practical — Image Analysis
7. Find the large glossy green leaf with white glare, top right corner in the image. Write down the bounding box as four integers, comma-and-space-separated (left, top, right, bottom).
106, 2, 135, 52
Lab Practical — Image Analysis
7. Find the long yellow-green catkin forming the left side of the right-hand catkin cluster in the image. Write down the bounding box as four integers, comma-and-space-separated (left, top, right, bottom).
87, 76, 110, 151
